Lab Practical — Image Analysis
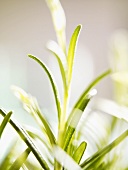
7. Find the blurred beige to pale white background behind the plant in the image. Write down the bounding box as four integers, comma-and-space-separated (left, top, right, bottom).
0, 0, 128, 119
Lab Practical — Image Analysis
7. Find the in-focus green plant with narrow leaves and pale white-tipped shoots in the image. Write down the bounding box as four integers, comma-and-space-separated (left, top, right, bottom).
0, 0, 128, 170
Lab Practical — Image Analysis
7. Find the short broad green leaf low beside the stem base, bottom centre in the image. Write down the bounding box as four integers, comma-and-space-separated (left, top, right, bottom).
73, 142, 87, 164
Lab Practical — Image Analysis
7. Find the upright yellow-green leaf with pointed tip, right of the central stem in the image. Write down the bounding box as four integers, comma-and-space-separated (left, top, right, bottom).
67, 25, 82, 86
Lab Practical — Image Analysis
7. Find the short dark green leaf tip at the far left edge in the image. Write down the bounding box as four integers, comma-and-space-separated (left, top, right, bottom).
0, 112, 12, 138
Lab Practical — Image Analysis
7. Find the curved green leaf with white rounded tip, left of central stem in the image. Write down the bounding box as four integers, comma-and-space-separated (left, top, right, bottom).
47, 41, 67, 92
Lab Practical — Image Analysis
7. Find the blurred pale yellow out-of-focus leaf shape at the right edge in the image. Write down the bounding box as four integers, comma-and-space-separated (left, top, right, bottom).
109, 29, 128, 106
